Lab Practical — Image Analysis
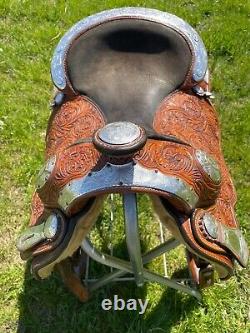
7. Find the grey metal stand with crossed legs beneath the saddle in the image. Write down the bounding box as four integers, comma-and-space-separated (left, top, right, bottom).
81, 193, 201, 300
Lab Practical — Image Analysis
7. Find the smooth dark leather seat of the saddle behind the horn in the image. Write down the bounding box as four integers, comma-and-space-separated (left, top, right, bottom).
66, 19, 192, 128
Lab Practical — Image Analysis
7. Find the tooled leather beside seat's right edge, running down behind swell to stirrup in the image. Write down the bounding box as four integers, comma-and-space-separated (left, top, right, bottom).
154, 91, 238, 227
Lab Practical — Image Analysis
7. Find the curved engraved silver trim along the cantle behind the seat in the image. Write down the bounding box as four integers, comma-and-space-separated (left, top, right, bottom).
51, 7, 208, 90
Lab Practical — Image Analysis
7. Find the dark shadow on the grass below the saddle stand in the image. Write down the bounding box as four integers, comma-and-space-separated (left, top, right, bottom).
17, 265, 198, 333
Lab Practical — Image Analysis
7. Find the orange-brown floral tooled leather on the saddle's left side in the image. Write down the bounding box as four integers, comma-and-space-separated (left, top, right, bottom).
31, 96, 105, 218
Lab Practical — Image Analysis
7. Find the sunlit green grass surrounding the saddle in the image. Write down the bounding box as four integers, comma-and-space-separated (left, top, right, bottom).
0, 0, 250, 333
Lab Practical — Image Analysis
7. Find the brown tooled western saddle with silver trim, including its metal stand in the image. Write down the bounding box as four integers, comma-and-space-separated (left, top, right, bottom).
17, 8, 248, 301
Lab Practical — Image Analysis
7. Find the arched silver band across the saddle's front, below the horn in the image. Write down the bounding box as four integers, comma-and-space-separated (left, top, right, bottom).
58, 162, 199, 211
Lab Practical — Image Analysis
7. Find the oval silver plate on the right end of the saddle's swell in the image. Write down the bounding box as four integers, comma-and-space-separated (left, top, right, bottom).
195, 150, 221, 183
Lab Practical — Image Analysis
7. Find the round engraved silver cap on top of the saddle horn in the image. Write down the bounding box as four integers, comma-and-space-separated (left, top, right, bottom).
98, 121, 141, 145
